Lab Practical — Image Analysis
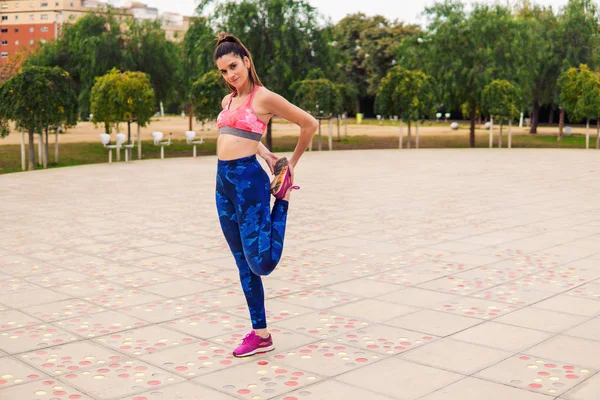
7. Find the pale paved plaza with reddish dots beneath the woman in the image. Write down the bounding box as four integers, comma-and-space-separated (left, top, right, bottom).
0, 149, 600, 400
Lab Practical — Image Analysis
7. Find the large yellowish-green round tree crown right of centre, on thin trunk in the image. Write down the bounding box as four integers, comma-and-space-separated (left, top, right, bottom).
376, 67, 436, 121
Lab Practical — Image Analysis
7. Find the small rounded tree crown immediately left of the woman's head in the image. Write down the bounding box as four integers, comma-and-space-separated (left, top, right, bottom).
191, 70, 227, 121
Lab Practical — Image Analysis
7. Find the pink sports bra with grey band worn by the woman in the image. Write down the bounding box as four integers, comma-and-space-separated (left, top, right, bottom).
217, 86, 267, 142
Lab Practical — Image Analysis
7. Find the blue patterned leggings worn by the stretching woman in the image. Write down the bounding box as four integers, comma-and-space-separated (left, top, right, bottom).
216, 155, 288, 329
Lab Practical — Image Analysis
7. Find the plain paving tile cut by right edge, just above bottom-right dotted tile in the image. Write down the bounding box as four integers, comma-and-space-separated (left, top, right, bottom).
525, 335, 600, 369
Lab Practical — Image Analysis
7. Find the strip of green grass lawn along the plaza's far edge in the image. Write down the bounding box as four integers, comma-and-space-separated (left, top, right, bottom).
0, 133, 596, 174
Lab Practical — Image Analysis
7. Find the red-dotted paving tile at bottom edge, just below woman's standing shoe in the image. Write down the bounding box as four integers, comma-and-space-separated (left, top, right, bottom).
192, 360, 321, 399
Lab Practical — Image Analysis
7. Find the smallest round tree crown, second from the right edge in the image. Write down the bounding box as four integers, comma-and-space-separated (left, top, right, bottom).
481, 80, 521, 122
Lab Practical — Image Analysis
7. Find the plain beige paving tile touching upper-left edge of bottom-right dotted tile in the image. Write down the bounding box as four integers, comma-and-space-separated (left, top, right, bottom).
399, 338, 511, 375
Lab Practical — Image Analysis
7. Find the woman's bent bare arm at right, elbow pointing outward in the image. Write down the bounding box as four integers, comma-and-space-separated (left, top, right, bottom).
259, 91, 319, 167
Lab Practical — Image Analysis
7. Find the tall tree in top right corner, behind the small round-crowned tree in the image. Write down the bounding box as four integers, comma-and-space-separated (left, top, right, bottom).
557, 0, 600, 140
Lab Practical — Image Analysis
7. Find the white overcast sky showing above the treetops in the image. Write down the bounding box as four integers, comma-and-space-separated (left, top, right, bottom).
113, 0, 568, 23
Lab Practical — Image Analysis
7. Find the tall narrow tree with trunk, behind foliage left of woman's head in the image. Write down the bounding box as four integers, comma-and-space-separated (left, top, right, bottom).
180, 17, 219, 131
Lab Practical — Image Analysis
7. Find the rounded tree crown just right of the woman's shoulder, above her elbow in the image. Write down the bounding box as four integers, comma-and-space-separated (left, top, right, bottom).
291, 79, 342, 116
